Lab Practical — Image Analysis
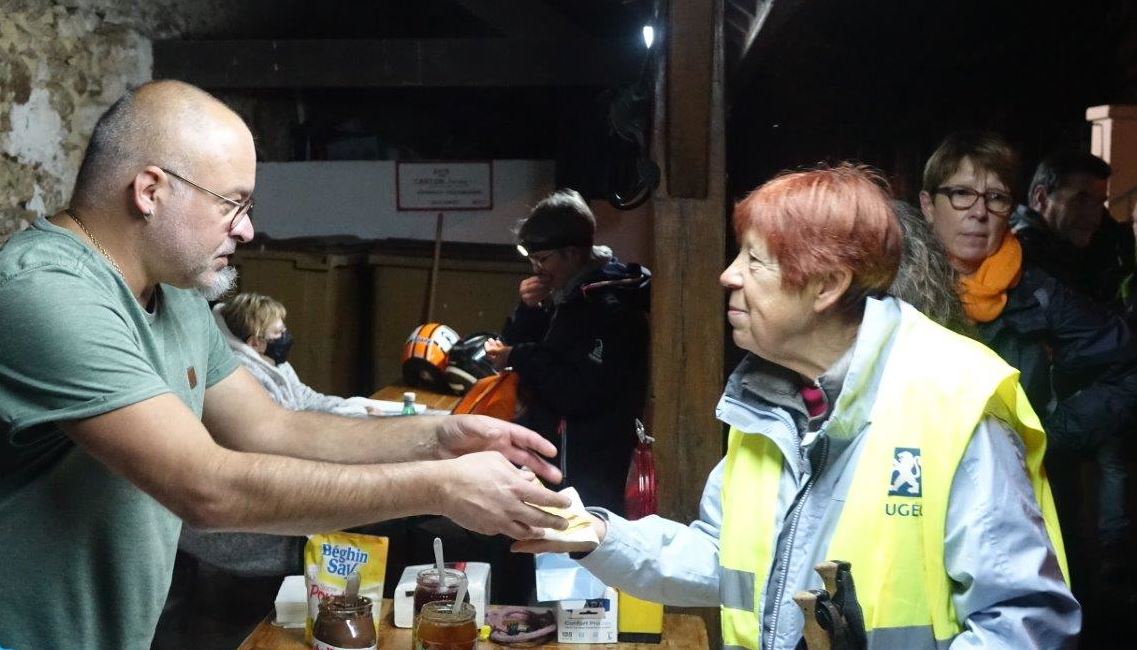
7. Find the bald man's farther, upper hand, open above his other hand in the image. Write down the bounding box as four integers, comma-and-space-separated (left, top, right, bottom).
438, 415, 563, 484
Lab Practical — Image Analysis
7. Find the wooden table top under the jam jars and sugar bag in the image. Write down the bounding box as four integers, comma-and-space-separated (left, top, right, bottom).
238, 598, 708, 650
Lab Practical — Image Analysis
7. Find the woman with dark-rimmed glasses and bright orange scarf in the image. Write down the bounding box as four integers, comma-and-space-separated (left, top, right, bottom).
920, 133, 1137, 592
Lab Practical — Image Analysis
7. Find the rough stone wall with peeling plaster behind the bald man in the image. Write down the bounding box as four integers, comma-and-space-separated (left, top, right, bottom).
0, 0, 152, 241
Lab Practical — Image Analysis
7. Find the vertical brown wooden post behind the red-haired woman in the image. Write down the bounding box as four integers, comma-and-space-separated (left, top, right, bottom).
649, 0, 727, 648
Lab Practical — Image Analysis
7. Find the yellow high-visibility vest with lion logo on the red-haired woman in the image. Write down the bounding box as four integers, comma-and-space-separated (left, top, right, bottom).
720, 309, 1069, 650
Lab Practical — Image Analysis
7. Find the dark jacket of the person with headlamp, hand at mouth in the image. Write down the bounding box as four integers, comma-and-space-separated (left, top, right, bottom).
501, 258, 652, 514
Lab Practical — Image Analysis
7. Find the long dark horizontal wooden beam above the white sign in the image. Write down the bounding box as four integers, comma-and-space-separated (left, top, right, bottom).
153, 39, 642, 89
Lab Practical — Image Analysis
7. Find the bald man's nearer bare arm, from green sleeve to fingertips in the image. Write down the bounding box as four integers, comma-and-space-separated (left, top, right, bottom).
61, 388, 567, 539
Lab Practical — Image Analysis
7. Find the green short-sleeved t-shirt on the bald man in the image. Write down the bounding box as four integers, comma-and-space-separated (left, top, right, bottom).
0, 219, 236, 650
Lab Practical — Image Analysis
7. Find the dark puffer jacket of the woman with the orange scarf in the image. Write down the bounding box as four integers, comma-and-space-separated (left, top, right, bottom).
979, 264, 1137, 453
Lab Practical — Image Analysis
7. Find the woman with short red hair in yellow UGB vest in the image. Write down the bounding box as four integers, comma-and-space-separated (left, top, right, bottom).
516, 165, 1080, 650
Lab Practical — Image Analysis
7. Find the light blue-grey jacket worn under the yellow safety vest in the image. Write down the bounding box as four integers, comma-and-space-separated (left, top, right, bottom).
581, 298, 1081, 650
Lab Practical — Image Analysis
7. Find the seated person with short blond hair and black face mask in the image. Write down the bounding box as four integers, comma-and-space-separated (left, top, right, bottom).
214, 293, 379, 417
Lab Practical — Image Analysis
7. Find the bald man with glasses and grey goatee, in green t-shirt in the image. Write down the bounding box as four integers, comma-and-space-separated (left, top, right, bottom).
0, 82, 569, 649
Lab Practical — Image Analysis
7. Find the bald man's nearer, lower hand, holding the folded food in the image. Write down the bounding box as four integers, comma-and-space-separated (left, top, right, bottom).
438, 451, 570, 540
